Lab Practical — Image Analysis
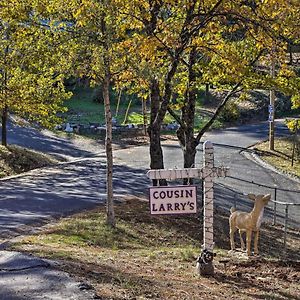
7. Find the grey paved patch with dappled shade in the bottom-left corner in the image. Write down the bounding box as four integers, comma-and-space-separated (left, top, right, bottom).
0, 251, 96, 300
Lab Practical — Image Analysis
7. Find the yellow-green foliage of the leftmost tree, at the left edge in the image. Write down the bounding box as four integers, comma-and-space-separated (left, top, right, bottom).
0, 0, 71, 124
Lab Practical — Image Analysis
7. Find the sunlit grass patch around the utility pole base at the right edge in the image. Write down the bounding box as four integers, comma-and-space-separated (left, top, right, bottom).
255, 137, 300, 177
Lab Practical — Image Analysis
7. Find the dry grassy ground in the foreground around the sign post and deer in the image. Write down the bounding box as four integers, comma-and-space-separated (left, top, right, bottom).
13, 200, 300, 299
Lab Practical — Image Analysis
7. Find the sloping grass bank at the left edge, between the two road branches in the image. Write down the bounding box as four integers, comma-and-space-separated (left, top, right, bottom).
0, 145, 57, 178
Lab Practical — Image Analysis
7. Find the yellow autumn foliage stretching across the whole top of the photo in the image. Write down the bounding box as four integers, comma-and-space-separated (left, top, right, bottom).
0, 0, 299, 129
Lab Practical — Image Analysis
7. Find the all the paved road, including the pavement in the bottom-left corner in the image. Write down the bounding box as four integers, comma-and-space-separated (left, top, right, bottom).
0, 119, 300, 300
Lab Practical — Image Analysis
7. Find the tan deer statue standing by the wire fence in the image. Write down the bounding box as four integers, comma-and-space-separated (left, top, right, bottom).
229, 194, 271, 256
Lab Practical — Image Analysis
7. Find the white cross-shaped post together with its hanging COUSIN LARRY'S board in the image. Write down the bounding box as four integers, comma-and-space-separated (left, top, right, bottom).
147, 141, 229, 275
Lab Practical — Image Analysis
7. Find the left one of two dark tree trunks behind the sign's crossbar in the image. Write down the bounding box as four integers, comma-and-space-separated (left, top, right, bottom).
148, 80, 167, 186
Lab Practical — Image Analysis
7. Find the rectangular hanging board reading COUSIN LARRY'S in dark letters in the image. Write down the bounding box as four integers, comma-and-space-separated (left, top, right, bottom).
150, 185, 197, 215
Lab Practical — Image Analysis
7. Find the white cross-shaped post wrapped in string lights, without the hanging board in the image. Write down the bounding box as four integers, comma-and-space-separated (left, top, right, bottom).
147, 141, 229, 275
